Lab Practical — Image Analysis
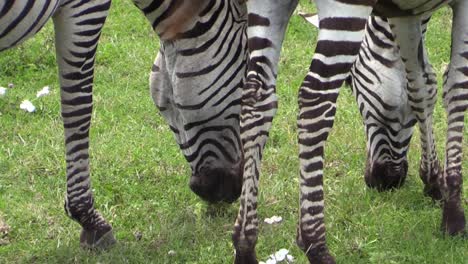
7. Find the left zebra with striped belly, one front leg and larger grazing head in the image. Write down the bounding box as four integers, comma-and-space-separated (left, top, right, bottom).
0, 0, 247, 248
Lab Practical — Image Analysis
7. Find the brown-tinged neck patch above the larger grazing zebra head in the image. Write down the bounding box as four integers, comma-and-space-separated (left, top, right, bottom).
134, 0, 210, 40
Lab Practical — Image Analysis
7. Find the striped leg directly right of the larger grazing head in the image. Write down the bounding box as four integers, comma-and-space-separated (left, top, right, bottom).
232, 0, 298, 264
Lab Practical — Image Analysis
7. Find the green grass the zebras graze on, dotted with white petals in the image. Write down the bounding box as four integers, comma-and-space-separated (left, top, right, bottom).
0, 0, 468, 263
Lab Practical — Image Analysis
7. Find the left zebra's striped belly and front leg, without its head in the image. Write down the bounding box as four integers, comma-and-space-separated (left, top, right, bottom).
0, 0, 114, 250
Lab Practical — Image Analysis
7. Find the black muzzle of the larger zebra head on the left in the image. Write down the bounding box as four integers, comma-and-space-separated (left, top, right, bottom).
190, 163, 243, 203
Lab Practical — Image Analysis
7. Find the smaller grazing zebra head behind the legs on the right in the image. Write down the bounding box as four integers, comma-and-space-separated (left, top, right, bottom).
349, 16, 416, 190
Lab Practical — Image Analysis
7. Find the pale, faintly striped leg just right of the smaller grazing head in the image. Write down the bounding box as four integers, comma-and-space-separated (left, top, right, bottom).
390, 17, 442, 200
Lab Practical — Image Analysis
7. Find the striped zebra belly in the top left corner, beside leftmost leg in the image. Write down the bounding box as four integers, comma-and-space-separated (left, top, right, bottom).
0, 0, 60, 51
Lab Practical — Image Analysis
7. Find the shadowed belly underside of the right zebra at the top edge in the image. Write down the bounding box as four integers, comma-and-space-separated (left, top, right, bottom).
373, 0, 452, 17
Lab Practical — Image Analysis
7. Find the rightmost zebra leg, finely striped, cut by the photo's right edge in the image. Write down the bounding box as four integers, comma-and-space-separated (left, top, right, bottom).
439, 1, 468, 235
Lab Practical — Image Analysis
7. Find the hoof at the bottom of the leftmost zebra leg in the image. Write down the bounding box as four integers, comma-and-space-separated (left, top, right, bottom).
80, 228, 117, 250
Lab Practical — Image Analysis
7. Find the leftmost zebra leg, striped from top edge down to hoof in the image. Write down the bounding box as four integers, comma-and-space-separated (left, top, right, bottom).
54, 0, 115, 248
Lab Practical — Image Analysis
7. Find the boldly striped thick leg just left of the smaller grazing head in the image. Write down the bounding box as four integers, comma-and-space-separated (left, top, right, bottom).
297, 0, 375, 263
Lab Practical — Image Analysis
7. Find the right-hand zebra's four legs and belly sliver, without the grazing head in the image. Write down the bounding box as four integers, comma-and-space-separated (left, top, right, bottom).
232, 0, 468, 263
